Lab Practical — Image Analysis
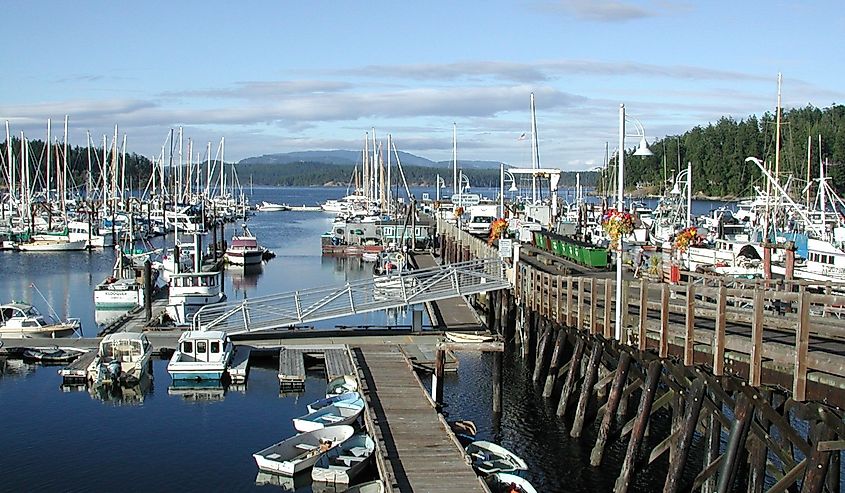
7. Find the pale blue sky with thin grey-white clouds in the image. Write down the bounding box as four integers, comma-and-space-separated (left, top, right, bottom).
0, 0, 845, 170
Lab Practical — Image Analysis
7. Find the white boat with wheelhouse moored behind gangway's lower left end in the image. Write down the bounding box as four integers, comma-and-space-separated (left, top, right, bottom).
166, 271, 226, 325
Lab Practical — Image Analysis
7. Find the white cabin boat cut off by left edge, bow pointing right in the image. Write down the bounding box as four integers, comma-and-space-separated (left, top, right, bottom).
0, 301, 82, 339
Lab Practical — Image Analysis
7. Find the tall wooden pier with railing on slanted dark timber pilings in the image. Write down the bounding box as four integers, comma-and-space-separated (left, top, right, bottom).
438, 221, 845, 493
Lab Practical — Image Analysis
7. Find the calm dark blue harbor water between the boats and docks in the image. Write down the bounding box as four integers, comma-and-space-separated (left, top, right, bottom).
0, 188, 740, 492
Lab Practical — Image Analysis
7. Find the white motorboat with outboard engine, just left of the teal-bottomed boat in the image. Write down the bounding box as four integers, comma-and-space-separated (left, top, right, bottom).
88, 332, 153, 385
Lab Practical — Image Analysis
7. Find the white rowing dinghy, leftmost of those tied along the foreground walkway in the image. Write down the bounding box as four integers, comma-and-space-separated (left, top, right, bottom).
252, 426, 355, 476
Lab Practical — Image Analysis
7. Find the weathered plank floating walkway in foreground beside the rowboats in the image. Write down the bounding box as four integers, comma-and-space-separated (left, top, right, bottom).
354, 345, 489, 492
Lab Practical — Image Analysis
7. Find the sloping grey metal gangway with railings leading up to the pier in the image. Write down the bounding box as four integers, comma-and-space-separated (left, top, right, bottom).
192, 258, 512, 335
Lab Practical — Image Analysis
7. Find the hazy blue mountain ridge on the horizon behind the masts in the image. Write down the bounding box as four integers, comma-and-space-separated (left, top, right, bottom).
238, 150, 499, 169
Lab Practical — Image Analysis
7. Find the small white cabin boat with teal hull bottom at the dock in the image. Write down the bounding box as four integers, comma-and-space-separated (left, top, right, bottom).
167, 330, 235, 381
